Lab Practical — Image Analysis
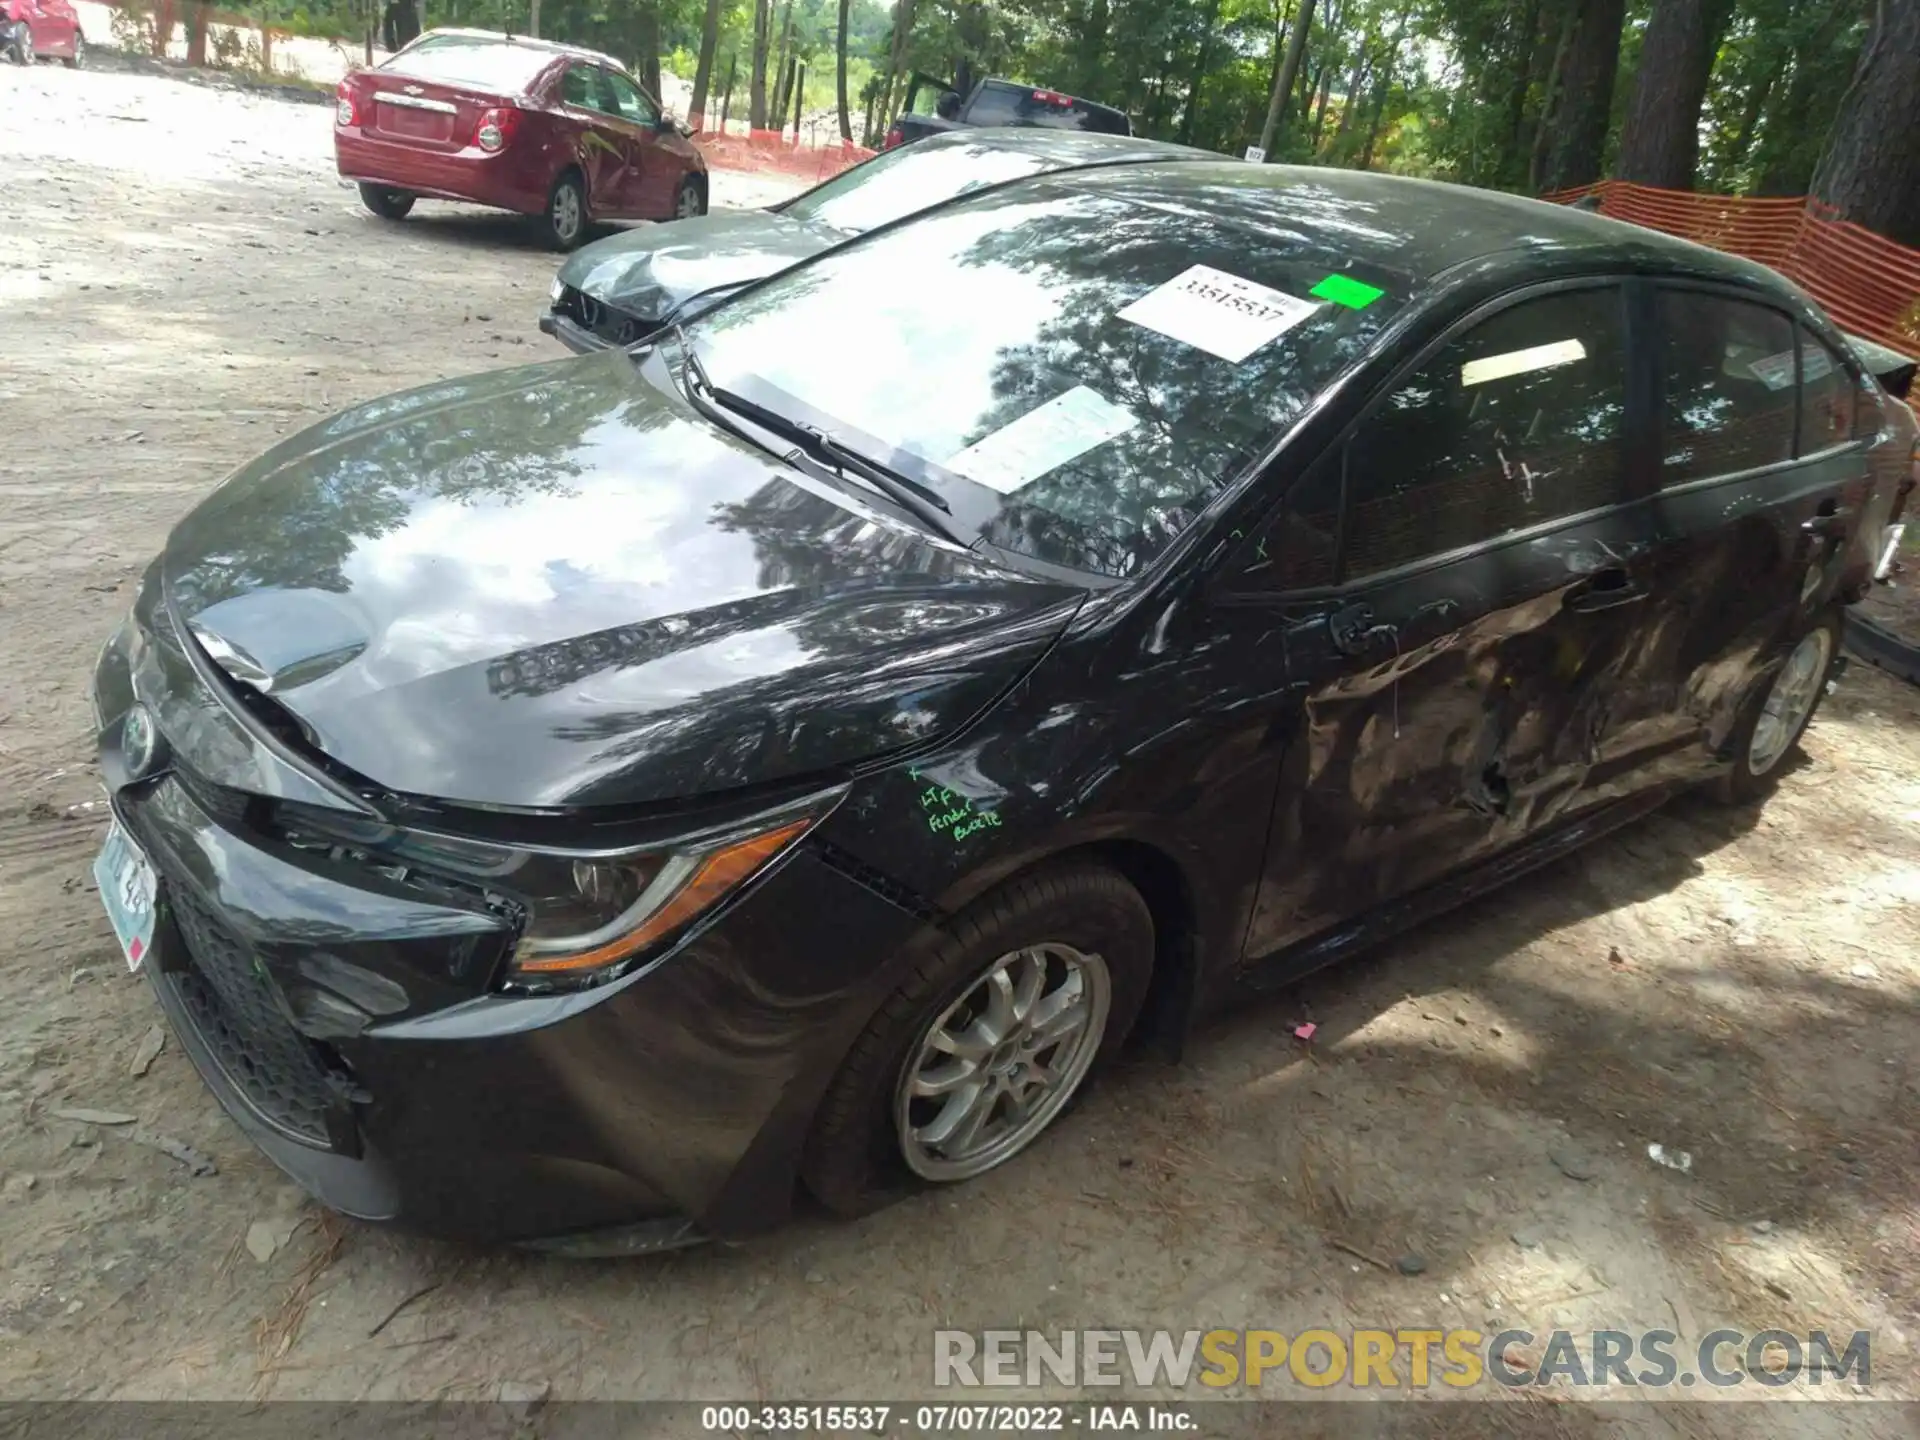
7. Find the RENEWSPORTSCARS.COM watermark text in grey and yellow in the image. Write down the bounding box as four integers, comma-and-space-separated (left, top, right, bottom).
933, 1329, 1872, 1390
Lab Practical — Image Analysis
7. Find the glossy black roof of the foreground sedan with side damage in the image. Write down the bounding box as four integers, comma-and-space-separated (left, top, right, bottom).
1021, 160, 1797, 294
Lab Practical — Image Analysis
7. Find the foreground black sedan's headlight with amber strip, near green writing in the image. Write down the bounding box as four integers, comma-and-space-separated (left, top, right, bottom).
280, 795, 837, 977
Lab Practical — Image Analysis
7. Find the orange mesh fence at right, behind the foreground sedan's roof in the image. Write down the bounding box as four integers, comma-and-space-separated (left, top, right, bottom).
1542, 180, 1920, 355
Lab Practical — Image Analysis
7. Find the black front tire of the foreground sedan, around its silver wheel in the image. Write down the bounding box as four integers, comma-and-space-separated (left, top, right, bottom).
801, 864, 1154, 1217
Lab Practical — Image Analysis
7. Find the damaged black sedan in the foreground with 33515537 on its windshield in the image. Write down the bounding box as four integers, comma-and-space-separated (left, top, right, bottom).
94, 163, 1914, 1250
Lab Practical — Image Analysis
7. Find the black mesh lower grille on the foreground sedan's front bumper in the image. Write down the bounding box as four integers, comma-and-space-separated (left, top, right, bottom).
161, 885, 338, 1148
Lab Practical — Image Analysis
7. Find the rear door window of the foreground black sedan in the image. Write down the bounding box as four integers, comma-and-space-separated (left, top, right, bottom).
1657, 290, 1795, 486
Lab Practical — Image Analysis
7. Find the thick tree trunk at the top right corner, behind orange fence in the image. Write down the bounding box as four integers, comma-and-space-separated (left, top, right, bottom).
1812, 0, 1920, 248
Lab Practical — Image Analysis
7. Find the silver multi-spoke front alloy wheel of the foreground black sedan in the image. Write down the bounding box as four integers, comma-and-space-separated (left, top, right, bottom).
895, 943, 1114, 1181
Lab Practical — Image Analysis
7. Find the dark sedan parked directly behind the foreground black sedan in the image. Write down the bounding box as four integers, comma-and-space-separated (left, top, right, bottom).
540, 129, 1219, 353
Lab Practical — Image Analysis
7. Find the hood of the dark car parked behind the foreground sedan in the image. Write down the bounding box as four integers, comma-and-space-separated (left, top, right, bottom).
561, 209, 847, 321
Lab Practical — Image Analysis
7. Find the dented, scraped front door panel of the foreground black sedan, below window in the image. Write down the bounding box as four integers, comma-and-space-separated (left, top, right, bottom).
1246, 515, 1645, 971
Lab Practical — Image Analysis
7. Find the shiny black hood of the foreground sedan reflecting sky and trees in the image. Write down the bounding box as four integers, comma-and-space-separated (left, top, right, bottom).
161, 351, 1083, 806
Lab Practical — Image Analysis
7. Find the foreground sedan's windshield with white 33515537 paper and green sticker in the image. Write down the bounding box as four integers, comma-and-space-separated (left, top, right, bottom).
689, 179, 1411, 576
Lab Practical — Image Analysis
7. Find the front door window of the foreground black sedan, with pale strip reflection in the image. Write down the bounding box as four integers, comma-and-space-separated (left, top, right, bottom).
1336, 286, 1626, 580
